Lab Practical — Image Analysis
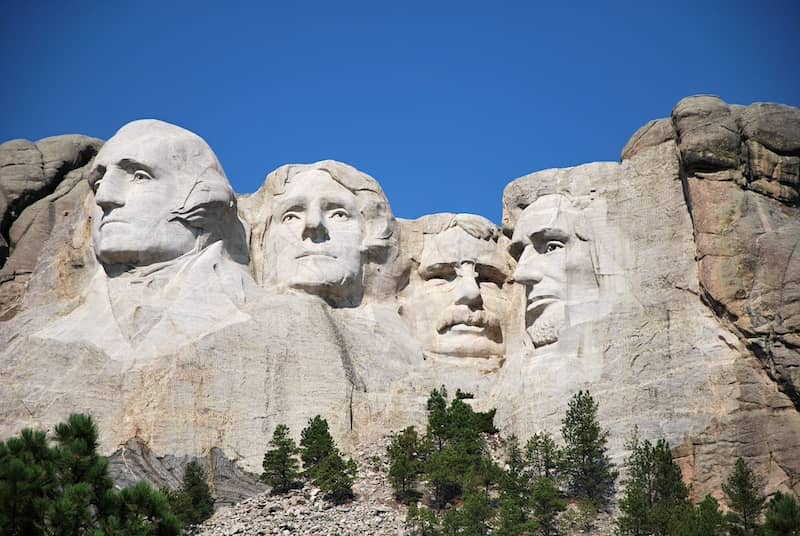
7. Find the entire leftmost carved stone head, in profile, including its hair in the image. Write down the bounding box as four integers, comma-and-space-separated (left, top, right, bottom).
89, 120, 241, 269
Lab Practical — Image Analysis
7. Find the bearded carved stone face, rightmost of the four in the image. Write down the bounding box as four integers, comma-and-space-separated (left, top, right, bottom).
510, 195, 582, 347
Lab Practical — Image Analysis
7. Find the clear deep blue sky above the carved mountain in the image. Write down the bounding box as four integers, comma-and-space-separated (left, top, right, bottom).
0, 0, 800, 222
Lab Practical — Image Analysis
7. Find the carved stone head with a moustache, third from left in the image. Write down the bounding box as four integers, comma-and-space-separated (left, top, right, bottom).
408, 215, 508, 358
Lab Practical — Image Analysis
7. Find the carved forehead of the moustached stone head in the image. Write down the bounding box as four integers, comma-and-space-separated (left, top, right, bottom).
420, 227, 508, 272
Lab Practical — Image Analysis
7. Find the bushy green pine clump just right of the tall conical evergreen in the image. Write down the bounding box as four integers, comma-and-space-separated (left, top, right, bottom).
617, 432, 692, 536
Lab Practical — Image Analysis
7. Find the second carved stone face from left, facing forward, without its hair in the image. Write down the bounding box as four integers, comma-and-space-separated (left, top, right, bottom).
267, 169, 364, 297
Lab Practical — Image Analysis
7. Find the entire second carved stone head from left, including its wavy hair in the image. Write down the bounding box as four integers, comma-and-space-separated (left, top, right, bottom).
265, 162, 394, 305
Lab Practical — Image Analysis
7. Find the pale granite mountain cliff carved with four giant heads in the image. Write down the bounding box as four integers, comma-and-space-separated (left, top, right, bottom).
0, 96, 800, 506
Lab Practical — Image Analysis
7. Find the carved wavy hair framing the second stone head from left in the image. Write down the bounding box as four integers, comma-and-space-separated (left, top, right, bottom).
265, 160, 395, 251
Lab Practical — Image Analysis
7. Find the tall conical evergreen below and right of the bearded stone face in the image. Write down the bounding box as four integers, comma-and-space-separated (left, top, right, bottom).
561, 391, 617, 507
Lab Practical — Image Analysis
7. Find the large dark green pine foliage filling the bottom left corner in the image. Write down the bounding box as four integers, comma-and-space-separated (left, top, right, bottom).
0, 414, 180, 536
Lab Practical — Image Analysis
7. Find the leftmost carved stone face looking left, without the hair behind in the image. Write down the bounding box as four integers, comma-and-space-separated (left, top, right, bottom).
89, 122, 198, 266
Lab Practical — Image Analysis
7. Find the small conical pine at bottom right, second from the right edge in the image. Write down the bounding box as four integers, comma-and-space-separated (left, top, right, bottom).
722, 458, 766, 536
